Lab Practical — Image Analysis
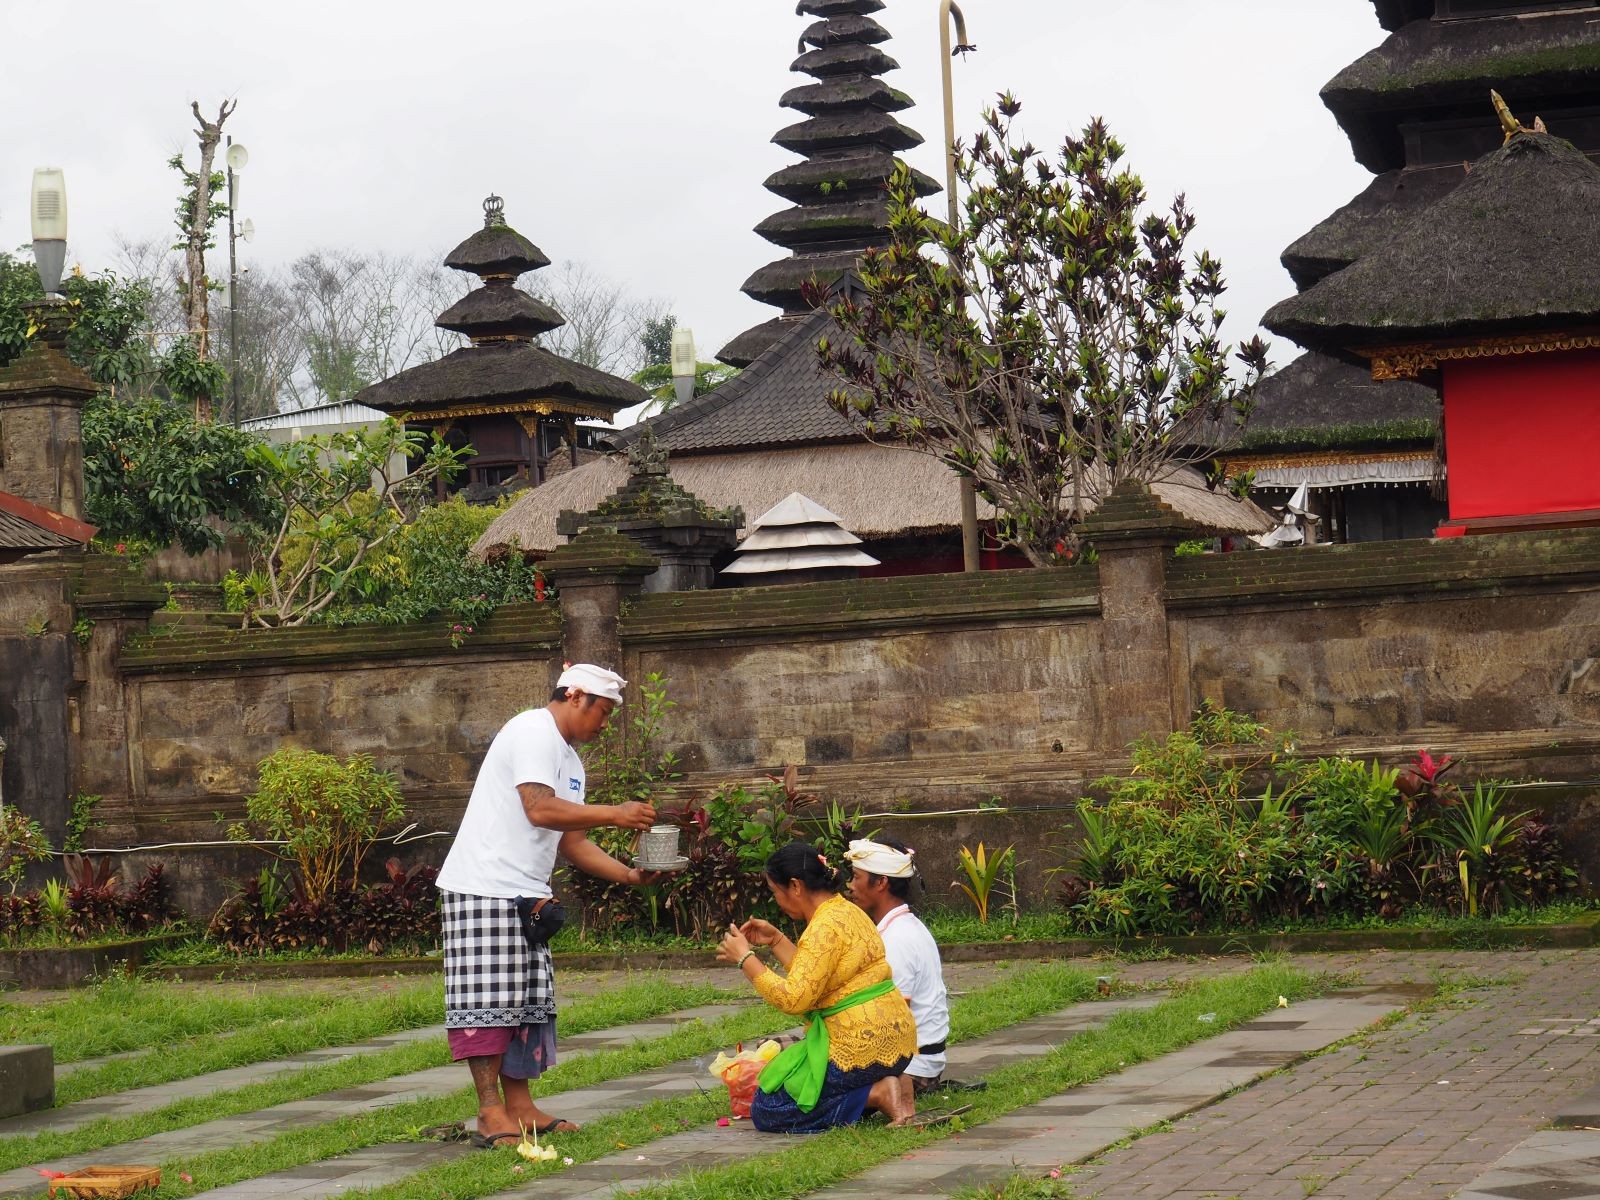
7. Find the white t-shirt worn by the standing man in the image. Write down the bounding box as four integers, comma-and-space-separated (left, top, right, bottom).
438, 709, 584, 899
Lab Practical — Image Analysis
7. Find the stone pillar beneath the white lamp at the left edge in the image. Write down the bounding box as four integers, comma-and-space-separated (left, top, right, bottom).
0, 301, 99, 520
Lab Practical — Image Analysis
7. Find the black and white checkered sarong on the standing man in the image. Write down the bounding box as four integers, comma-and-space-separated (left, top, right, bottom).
440, 891, 555, 1029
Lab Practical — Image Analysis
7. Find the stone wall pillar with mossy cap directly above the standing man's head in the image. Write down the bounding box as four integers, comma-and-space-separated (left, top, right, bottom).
539, 528, 661, 683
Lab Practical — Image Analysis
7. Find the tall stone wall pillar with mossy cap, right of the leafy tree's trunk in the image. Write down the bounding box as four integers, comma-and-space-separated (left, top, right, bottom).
1082, 483, 1198, 752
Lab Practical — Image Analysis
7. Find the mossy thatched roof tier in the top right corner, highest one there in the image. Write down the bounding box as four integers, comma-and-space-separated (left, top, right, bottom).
1322, 5, 1600, 171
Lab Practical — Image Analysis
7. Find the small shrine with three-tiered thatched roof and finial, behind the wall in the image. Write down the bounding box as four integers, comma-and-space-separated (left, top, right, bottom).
355, 195, 650, 490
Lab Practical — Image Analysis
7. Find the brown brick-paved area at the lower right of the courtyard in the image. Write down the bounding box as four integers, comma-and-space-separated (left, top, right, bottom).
1062, 950, 1600, 1200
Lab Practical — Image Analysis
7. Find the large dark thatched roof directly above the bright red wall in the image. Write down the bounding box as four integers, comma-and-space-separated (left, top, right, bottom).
1262, 133, 1600, 350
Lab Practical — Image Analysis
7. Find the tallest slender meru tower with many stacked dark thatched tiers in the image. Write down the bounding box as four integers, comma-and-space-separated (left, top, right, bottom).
717, 0, 939, 366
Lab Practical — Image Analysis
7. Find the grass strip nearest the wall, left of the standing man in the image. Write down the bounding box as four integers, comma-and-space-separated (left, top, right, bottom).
0, 974, 443, 1066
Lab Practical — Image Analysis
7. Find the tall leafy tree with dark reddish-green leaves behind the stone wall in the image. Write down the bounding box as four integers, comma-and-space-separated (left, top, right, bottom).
813, 94, 1266, 563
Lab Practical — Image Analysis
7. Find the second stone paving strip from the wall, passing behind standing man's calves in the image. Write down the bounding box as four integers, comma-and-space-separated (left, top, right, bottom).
0, 1005, 752, 1197
